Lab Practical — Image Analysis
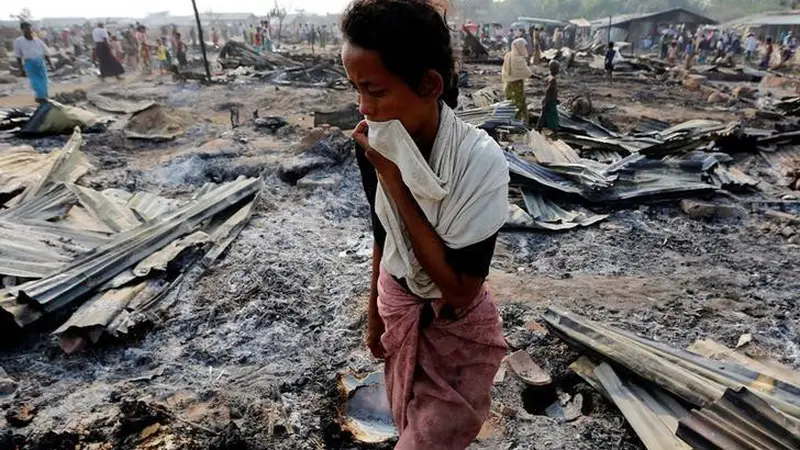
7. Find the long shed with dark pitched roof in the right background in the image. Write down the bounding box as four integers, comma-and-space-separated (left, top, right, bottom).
592, 8, 717, 50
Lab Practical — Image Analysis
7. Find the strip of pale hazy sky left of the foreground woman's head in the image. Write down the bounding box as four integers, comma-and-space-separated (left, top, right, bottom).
0, 0, 348, 20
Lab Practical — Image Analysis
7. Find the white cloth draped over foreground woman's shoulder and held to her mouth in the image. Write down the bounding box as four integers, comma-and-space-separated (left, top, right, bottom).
367, 105, 509, 299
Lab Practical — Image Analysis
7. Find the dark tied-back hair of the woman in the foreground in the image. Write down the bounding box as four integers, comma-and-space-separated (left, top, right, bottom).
341, 0, 458, 108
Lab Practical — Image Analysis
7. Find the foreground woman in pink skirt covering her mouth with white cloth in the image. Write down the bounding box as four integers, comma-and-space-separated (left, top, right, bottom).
341, 0, 509, 450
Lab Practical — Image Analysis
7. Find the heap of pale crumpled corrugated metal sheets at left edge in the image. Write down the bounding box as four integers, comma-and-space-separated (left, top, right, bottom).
0, 130, 260, 353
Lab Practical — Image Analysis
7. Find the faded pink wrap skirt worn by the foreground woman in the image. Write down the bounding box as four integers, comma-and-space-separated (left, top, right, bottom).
378, 268, 506, 450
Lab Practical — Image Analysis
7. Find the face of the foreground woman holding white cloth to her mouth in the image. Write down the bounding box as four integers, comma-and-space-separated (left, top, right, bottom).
342, 42, 443, 136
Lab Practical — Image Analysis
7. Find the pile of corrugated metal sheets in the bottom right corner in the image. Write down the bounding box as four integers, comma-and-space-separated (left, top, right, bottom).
545, 307, 800, 450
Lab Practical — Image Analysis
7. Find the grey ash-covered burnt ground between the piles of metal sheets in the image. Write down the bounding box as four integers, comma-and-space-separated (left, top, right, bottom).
0, 60, 800, 450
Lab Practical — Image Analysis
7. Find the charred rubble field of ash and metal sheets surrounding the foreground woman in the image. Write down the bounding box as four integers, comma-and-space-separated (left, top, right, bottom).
0, 26, 800, 450
